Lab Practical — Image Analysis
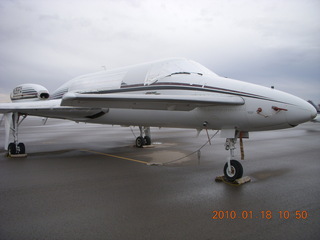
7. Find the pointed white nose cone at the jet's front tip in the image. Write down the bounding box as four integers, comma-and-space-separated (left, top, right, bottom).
286, 98, 317, 126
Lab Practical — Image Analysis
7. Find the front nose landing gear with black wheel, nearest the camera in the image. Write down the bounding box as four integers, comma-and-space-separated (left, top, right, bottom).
223, 138, 243, 182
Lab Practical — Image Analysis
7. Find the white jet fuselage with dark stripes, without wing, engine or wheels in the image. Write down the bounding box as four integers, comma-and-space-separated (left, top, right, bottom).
49, 59, 315, 131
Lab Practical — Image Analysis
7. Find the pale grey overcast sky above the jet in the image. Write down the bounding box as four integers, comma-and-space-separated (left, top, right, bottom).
0, 0, 320, 103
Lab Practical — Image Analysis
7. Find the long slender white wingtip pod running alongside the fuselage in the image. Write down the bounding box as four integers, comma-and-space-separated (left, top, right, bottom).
61, 93, 244, 111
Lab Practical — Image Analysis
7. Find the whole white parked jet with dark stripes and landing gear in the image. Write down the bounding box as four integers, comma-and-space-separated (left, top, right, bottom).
0, 58, 317, 181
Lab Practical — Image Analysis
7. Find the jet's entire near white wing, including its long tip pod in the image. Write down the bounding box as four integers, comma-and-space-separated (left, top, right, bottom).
0, 93, 244, 121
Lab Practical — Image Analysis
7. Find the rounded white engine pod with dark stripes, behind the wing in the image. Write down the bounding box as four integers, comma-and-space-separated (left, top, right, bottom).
10, 83, 50, 101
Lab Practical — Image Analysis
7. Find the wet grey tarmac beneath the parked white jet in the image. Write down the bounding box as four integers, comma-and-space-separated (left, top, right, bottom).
0, 118, 320, 240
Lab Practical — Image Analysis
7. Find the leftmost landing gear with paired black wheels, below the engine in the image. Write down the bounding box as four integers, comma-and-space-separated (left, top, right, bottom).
7, 113, 27, 157
